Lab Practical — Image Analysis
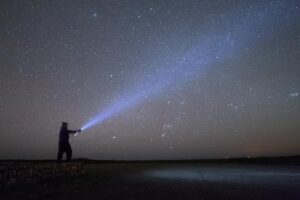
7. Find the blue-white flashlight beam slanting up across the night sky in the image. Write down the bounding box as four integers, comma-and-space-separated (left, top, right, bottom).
81, 4, 282, 130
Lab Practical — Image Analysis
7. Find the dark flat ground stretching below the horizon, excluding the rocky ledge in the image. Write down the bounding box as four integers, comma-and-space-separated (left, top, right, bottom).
0, 162, 300, 200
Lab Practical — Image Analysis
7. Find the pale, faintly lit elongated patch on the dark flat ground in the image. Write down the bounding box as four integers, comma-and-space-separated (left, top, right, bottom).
144, 165, 300, 185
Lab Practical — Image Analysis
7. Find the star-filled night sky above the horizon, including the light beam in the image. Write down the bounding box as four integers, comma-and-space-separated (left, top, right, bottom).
0, 0, 300, 160
